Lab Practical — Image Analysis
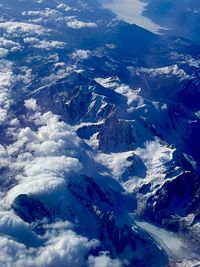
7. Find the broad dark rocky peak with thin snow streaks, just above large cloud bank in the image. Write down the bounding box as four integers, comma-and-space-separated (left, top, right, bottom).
33, 73, 92, 124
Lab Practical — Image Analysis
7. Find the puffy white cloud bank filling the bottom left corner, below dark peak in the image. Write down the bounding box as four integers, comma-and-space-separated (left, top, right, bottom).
0, 230, 98, 267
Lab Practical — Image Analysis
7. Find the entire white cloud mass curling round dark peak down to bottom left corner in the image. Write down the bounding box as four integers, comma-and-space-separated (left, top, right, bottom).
0, 104, 99, 267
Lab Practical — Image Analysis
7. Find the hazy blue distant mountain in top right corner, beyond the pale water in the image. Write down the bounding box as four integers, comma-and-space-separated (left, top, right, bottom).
143, 0, 200, 44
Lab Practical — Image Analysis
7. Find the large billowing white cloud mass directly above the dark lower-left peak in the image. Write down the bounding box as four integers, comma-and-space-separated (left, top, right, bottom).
5, 110, 82, 205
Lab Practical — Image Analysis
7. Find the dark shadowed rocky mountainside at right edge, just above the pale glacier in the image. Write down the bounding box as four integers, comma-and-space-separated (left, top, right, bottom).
145, 171, 200, 231
